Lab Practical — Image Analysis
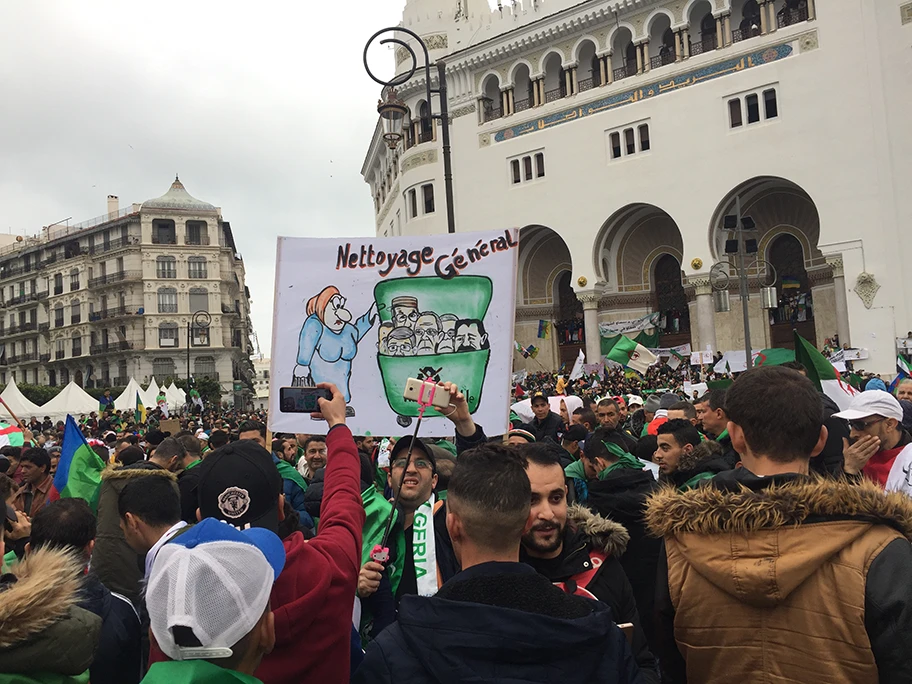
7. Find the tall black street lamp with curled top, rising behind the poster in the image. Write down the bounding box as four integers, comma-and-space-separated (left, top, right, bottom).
364, 26, 456, 233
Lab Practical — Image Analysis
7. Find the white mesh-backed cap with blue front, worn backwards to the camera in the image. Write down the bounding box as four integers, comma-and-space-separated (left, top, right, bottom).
146, 518, 285, 660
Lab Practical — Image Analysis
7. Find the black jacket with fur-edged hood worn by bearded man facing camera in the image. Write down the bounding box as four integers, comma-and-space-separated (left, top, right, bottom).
519, 506, 659, 684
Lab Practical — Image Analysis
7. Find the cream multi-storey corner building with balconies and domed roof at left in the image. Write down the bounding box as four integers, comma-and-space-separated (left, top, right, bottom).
0, 179, 253, 405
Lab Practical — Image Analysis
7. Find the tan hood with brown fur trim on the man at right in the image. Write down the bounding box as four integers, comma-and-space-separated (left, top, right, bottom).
646, 472, 912, 606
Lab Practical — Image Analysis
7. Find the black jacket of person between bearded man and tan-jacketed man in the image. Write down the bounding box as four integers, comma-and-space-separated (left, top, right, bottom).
586, 468, 662, 647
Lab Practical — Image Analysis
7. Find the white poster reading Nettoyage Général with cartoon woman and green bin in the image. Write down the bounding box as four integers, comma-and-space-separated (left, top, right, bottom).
269, 230, 519, 437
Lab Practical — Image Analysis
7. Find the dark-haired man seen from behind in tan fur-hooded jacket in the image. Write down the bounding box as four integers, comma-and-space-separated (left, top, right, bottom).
647, 367, 912, 684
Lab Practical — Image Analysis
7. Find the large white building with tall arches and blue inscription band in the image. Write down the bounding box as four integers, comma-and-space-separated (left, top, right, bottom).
362, 0, 912, 373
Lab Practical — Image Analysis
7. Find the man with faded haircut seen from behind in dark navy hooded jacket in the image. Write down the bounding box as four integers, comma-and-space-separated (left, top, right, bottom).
352, 444, 641, 684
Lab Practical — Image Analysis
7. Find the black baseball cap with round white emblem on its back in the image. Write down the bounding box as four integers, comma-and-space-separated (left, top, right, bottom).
197, 439, 282, 533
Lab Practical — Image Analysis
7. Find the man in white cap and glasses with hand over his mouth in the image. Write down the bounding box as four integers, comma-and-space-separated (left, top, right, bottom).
833, 390, 912, 494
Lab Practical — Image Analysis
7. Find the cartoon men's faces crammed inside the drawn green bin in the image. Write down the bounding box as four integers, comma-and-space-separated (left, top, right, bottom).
377, 296, 490, 356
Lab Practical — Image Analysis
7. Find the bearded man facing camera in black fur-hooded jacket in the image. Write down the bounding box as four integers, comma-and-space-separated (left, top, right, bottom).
518, 444, 659, 683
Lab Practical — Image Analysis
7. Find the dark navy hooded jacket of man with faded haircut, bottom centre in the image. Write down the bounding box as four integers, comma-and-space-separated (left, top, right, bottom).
352, 563, 642, 684
